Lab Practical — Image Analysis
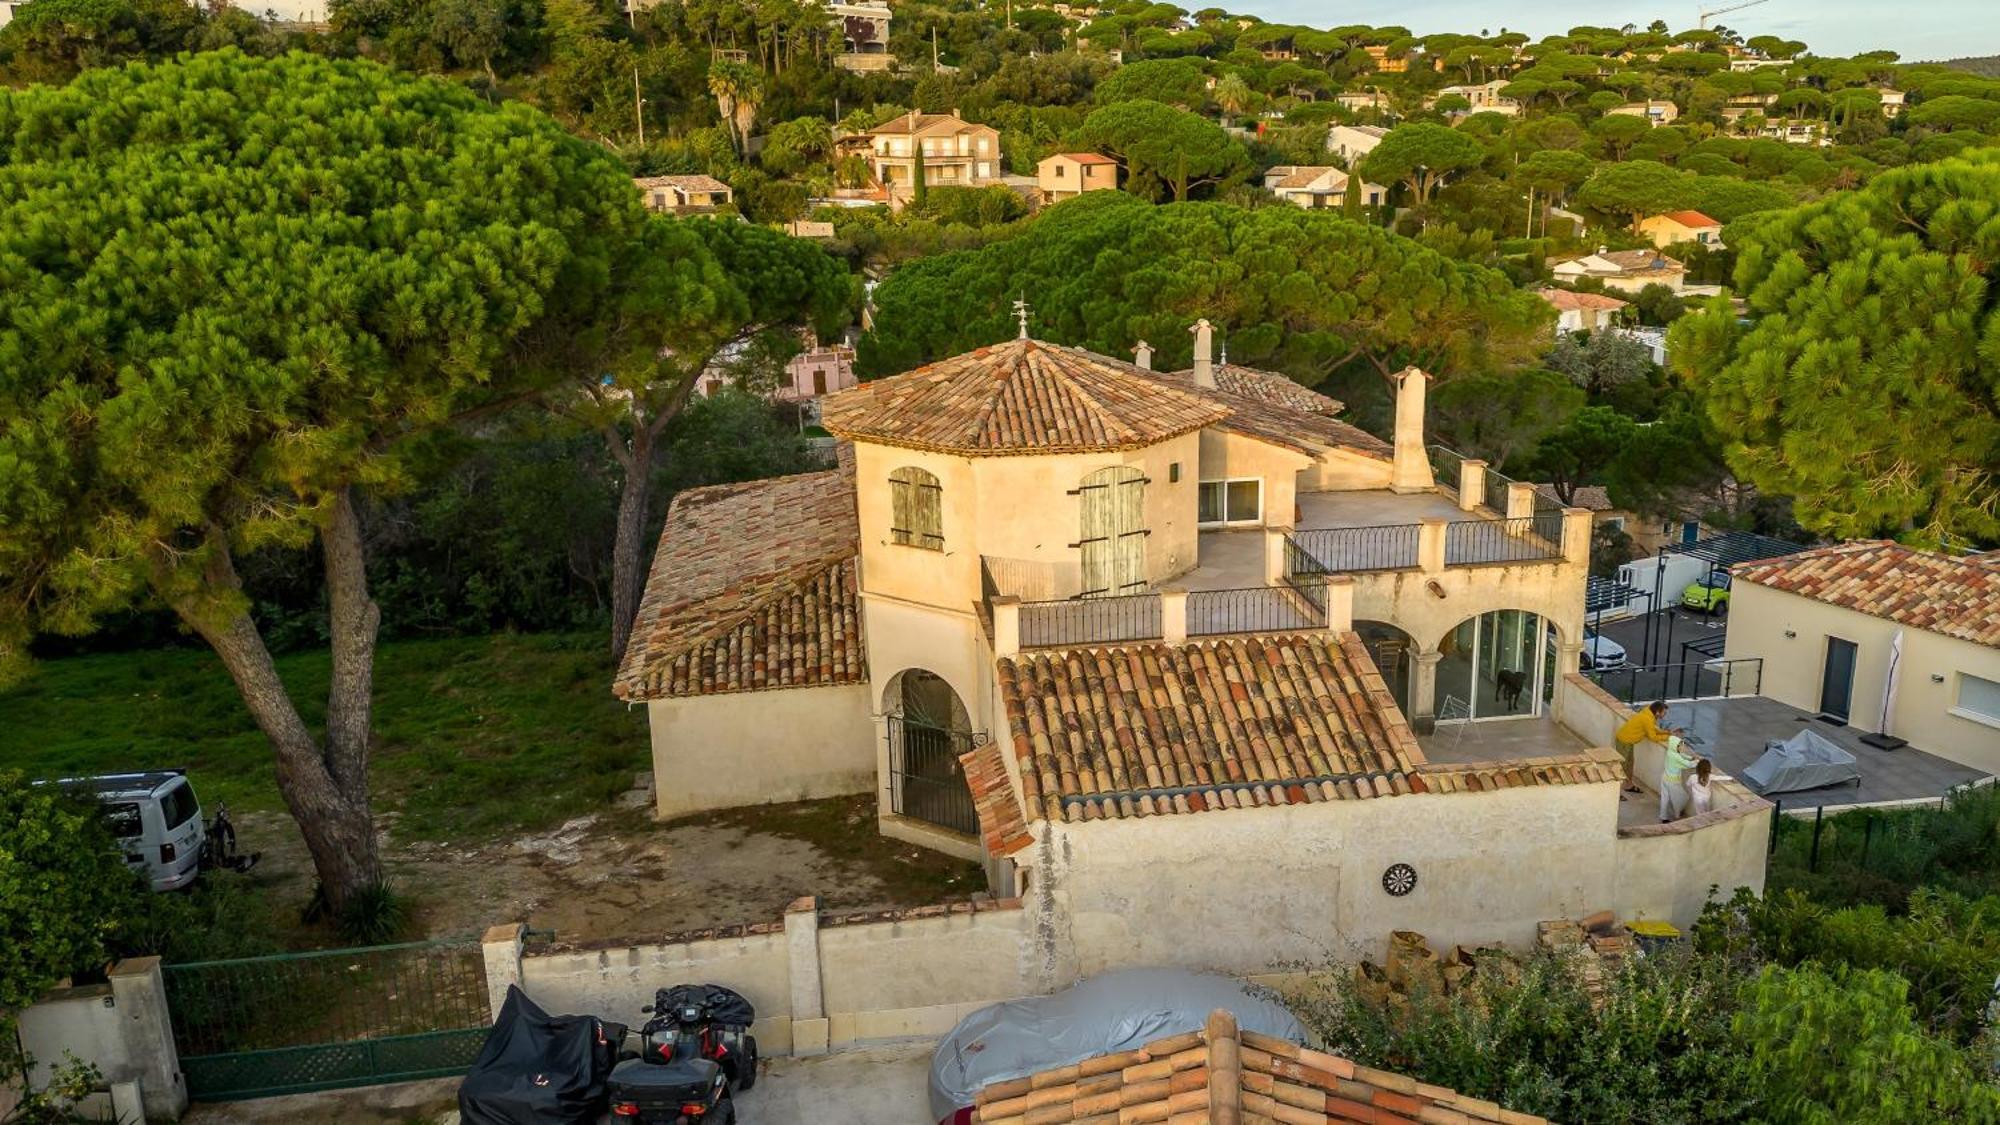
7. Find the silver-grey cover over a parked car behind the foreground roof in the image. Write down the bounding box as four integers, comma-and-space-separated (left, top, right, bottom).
930, 969, 1306, 1121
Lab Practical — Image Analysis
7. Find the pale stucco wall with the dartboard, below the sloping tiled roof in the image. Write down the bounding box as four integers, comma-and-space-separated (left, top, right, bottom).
1018, 783, 1618, 975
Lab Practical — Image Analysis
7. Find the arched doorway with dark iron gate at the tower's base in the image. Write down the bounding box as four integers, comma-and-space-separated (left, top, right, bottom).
882, 669, 980, 837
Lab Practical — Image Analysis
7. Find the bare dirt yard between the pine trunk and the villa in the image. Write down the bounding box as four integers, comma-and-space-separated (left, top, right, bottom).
238, 789, 984, 941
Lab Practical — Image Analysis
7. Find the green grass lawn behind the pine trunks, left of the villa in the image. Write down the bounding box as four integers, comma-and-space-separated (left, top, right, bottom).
0, 633, 650, 841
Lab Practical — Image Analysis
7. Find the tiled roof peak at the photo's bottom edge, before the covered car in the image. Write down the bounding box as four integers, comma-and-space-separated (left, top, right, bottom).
972, 1011, 1542, 1125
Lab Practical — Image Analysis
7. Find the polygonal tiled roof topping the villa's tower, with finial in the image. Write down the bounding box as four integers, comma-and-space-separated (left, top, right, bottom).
824, 340, 1228, 456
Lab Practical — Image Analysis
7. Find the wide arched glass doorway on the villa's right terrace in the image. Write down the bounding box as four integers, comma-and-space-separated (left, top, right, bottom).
1434, 609, 1556, 719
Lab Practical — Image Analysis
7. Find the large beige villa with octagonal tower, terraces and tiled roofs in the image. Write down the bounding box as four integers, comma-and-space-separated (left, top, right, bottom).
614, 320, 1768, 973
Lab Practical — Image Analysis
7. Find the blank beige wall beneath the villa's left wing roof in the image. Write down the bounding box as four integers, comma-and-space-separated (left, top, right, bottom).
646, 683, 876, 817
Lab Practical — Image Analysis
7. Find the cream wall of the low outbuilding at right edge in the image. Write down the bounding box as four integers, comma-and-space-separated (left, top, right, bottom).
1724, 583, 2000, 773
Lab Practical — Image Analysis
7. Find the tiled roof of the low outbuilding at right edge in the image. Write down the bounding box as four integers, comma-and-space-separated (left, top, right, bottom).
1734, 538, 2000, 647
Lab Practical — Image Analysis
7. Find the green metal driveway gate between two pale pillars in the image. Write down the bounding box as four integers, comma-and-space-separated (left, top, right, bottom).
164, 939, 490, 1101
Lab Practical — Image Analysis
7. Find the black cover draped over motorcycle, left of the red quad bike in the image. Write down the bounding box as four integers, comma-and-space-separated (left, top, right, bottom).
458, 985, 616, 1125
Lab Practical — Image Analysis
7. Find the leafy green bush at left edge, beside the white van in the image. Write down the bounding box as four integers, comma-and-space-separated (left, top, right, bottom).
0, 771, 136, 1013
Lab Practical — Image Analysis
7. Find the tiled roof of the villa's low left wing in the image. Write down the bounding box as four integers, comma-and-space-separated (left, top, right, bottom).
612, 468, 868, 699
